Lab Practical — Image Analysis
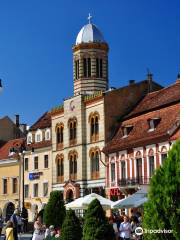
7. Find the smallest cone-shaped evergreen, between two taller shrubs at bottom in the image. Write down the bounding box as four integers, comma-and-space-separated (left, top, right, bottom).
61, 209, 82, 240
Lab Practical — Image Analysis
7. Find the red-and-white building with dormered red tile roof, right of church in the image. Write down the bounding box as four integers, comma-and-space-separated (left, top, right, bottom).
103, 79, 180, 199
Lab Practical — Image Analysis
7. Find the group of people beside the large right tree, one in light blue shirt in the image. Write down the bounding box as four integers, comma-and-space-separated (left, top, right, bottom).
109, 211, 142, 240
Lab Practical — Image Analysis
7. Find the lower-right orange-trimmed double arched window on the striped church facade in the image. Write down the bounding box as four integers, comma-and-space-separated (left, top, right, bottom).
90, 148, 100, 179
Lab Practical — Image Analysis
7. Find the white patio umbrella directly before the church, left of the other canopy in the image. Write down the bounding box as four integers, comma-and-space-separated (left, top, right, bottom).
65, 193, 113, 210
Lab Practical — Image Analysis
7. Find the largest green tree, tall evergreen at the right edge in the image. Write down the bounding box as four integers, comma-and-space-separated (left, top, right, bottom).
143, 140, 180, 240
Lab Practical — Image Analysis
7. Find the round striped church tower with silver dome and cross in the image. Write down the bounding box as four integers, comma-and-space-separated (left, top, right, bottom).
73, 15, 109, 95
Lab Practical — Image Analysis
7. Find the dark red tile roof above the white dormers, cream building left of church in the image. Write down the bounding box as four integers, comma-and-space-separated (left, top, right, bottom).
29, 112, 51, 131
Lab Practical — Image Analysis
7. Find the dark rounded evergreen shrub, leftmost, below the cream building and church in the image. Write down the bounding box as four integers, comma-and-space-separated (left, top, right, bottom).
43, 191, 66, 228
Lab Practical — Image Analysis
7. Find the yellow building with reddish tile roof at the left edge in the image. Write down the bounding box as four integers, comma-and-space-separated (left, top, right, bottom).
0, 139, 24, 221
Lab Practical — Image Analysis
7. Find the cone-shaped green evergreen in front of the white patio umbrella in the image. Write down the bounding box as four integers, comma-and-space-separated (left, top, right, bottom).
83, 199, 115, 240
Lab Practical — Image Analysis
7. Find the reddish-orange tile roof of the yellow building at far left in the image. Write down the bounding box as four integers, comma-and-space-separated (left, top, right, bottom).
0, 138, 24, 160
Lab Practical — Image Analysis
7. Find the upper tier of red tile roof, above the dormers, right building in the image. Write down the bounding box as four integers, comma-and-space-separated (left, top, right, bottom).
126, 81, 180, 119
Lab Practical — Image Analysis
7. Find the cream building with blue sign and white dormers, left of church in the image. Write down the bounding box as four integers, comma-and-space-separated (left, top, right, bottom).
24, 112, 52, 220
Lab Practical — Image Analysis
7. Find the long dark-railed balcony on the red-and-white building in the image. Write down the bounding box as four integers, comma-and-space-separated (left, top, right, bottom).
118, 177, 151, 188
